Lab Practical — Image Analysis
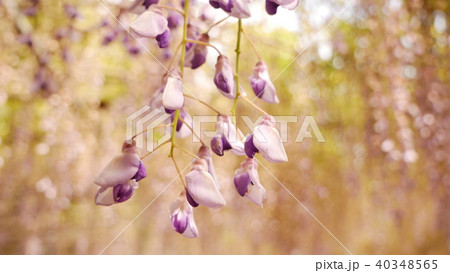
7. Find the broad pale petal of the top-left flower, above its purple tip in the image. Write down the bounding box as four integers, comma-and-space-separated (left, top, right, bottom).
130, 10, 168, 38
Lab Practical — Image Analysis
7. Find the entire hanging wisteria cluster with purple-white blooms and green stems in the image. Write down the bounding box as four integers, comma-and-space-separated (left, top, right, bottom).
94, 0, 299, 238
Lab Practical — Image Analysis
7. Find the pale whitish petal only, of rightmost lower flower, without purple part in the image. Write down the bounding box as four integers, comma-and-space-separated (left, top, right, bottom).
253, 117, 288, 163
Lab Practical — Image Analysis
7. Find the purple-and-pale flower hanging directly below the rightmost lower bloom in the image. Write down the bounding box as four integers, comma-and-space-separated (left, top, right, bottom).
234, 157, 266, 207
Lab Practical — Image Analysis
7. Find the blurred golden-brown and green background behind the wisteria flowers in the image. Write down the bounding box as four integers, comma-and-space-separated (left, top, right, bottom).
0, 0, 450, 254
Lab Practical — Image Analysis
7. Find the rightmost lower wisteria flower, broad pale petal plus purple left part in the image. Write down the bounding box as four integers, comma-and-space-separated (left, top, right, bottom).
245, 115, 288, 163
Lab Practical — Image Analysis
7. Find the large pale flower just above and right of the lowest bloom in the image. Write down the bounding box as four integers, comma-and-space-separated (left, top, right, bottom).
186, 148, 226, 208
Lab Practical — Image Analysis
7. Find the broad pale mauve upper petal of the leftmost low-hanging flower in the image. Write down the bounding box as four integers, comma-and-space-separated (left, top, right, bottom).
94, 153, 141, 187
